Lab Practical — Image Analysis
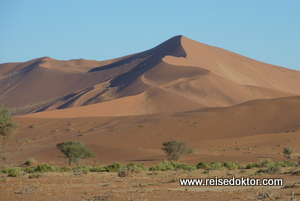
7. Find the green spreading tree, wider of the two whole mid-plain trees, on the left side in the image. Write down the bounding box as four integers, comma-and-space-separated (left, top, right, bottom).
56, 140, 95, 166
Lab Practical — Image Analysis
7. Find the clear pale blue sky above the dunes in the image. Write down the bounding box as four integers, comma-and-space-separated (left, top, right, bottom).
0, 0, 300, 70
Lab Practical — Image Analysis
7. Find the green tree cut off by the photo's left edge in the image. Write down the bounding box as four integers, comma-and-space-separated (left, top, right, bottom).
0, 104, 17, 144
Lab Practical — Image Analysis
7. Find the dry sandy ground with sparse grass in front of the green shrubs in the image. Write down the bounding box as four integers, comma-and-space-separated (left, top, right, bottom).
0, 168, 300, 200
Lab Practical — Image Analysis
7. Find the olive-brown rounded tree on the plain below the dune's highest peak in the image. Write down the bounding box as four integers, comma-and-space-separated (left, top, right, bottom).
162, 140, 194, 161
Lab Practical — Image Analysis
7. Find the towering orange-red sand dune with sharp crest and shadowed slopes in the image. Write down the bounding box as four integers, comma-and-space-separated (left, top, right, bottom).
0, 36, 300, 116
